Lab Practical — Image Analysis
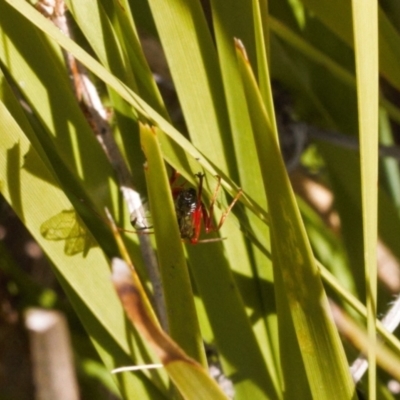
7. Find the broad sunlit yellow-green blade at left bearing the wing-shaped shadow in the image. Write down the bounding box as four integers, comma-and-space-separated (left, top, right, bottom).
0, 96, 165, 399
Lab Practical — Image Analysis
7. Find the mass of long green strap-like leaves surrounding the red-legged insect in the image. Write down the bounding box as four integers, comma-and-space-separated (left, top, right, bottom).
0, 0, 400, 400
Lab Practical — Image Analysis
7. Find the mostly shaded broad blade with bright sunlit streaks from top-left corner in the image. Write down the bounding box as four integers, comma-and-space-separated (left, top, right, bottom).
0, 7, 147, 267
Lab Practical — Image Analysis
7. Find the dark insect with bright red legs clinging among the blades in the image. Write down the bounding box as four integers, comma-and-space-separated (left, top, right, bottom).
171, 172, 242, 244
